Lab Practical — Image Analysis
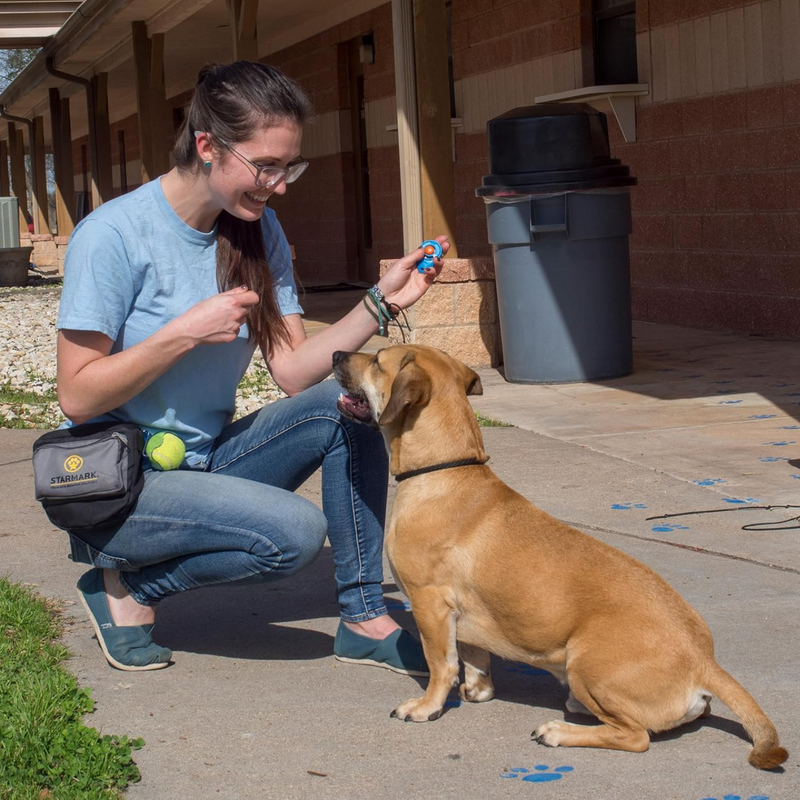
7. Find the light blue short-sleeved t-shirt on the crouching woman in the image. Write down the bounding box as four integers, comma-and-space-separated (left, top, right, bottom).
58, 179, 303, 468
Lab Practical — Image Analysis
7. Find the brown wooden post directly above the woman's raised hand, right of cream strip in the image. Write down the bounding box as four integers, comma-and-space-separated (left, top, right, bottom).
414, 0, 458, 253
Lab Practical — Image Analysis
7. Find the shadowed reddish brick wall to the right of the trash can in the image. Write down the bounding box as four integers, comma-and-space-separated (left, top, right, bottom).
628, 0, 800, 339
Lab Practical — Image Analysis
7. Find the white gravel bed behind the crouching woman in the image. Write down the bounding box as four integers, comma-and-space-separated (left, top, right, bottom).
0, 287, 284, 427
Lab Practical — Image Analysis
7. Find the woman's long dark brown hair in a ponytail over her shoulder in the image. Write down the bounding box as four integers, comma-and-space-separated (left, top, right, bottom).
173, 61, 313, 358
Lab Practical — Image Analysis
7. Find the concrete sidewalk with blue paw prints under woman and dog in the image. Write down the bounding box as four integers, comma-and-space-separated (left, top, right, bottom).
0, 324, 800, 800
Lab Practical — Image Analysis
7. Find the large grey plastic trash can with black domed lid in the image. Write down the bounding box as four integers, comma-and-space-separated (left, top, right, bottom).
476, 103, 636, 383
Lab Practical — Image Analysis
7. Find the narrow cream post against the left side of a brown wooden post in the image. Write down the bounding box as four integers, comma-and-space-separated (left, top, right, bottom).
392, 0, 425, 253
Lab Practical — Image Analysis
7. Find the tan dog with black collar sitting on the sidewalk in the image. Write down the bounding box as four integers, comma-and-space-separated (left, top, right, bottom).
333, 345, 788, 769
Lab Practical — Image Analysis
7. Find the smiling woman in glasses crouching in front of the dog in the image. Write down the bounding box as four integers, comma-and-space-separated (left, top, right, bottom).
58, 62, 448, 674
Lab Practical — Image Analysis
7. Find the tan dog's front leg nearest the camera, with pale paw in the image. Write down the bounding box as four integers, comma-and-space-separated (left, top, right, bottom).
391, 588, 458, 722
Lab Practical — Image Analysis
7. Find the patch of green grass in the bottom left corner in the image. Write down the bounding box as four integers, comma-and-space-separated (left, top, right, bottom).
0, 578, 144, 800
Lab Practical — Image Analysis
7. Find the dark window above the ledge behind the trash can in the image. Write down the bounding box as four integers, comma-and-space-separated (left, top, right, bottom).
594, 0, 639, 86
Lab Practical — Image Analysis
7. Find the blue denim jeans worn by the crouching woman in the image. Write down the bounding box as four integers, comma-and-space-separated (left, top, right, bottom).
70, 381, 388, 622
